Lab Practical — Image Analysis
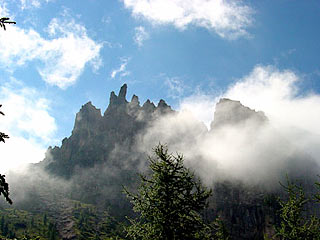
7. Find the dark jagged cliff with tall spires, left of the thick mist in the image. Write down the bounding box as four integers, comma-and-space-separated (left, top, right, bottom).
42, 84, 174, 178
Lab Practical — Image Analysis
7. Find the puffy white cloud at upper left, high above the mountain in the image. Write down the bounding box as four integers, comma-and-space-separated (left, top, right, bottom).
0, 12, 102, 89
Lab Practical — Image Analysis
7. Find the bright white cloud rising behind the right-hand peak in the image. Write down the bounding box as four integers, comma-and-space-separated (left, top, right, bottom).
224, 66, 320, 158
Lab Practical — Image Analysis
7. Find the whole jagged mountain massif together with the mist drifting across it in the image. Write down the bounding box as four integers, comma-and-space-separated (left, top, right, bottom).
1, 84, 319, 239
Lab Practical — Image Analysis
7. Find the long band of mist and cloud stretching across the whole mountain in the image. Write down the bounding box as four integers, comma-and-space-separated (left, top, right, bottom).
5, 66, 320, 207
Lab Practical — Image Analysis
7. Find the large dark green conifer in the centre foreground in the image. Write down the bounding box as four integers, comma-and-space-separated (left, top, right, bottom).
124, 144, 212, 240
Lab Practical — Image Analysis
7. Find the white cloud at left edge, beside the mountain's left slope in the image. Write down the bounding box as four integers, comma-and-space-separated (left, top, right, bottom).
0, 82, 57, 173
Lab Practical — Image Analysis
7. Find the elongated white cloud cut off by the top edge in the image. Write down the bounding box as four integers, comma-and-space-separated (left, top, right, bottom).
122, 0, 253, 38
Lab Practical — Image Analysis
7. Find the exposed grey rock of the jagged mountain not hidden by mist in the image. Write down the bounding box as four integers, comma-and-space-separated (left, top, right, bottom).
13, 84, 315, 239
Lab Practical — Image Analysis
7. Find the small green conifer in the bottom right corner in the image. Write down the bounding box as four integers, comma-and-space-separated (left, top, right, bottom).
275, 179, 320, 240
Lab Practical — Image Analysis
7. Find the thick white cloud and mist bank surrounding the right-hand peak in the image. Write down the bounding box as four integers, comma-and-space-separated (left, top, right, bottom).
137, 66, 320, 188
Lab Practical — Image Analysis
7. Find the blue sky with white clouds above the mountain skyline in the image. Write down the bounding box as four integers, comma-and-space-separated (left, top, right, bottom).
0, 0, 320, 170
